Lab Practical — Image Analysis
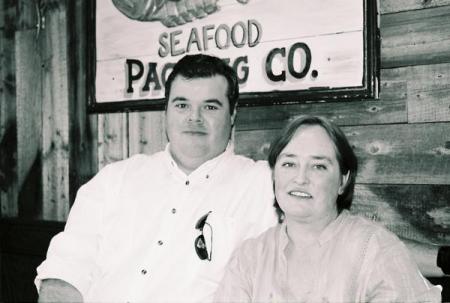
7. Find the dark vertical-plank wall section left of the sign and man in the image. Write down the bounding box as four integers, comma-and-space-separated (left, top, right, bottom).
0, 0, 97, 221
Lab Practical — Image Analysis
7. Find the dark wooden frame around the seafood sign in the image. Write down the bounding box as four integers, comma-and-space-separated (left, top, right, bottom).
86, 0, 380, 113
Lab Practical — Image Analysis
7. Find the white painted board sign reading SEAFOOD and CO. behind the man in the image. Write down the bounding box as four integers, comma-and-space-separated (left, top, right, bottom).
91, 0, 373, 111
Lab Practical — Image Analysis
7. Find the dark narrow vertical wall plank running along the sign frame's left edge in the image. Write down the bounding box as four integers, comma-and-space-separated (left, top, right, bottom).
67, 0, 98, 204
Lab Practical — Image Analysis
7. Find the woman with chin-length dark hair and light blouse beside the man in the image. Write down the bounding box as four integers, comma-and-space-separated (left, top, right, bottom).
215, 117, 441, 302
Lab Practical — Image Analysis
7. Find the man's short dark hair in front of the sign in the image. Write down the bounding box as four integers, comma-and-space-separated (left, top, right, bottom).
165, 54, 239, 114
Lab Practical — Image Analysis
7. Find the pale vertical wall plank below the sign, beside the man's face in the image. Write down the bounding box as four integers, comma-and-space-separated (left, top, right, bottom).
129, 111, 167, 156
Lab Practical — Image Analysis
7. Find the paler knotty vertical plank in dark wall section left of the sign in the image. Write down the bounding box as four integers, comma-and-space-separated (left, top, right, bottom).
39, 1, 69, 221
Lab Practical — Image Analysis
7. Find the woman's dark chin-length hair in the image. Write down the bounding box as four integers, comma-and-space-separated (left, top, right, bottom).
269, 116, 358, 222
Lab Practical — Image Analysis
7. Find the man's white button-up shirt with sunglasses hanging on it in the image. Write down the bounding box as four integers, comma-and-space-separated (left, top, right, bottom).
35, 146, 276, 302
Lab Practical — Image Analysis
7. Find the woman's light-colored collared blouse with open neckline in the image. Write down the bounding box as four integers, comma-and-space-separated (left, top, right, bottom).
215, 210, 441, 302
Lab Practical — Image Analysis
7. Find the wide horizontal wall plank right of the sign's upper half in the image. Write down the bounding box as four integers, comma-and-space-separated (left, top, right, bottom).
380, 5, 450, 68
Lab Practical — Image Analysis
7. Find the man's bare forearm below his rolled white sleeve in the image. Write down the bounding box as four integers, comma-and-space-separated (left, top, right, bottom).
38, 279, 83, 303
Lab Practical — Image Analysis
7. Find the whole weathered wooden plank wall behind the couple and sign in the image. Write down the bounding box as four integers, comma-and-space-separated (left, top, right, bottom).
0, 0, 450, 301
